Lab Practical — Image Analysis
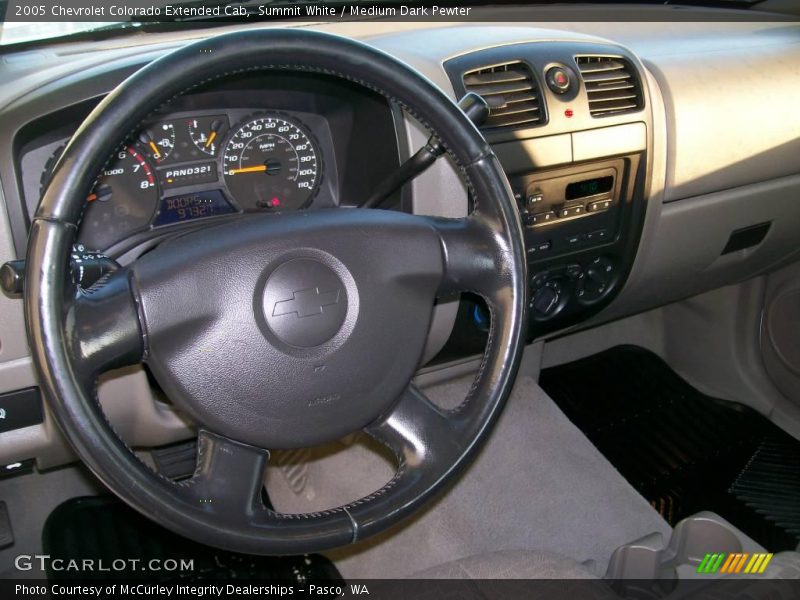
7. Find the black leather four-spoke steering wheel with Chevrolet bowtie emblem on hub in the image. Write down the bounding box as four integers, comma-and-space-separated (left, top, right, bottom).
25, 29, 526, 554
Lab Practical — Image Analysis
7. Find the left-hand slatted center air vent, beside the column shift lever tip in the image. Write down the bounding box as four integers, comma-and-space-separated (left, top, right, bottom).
464, 62, 544, 129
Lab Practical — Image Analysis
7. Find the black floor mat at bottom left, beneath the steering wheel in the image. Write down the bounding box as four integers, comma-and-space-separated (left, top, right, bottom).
42, 496, 342, 584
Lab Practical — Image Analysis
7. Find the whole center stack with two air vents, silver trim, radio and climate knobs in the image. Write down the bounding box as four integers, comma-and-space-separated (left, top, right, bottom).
445, 42, 652, 345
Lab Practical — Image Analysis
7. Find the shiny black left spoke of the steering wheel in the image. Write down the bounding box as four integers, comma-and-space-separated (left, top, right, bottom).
65, 270, 144, 378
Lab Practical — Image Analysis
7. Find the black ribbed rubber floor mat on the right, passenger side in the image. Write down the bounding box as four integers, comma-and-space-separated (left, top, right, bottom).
540, 346, 800, 552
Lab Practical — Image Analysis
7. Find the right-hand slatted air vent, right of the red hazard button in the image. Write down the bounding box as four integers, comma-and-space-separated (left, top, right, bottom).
575, 56, 643, 117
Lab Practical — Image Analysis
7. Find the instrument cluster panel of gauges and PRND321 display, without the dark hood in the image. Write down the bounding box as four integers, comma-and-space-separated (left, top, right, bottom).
39, 109, 336, 250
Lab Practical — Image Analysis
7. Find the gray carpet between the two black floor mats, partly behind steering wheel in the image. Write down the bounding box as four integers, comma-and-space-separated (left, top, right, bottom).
268, 378, 671, 578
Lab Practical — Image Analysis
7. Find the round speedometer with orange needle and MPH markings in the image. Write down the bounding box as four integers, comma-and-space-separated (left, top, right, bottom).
222, 114, 322, 211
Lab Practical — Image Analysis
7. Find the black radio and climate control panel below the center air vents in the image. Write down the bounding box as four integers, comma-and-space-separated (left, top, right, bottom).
509, 149, 642, 335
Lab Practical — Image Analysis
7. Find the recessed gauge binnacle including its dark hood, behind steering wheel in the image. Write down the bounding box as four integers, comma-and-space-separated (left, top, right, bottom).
19, 76, 399, 255
